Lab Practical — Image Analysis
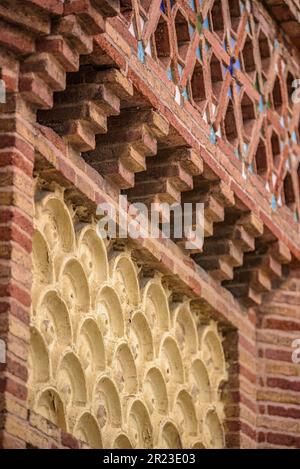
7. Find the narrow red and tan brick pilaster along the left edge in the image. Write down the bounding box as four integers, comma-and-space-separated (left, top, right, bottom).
0, 94, 34, 448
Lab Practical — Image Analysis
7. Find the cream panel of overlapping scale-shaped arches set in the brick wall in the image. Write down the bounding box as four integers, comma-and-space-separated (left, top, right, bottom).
29, 188, 227, 449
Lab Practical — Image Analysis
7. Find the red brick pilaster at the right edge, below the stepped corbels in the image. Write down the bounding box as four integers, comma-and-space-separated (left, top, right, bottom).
257, 270, 300, 448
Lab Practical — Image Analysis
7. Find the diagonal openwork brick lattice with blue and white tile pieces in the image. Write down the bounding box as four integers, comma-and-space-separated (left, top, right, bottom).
127, 0, 300, 220
